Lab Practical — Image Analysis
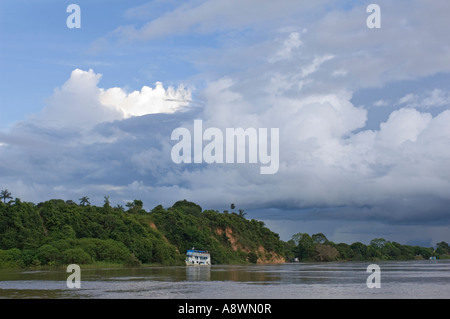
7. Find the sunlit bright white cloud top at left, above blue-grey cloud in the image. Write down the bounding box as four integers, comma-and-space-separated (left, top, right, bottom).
36, 69, 191, 128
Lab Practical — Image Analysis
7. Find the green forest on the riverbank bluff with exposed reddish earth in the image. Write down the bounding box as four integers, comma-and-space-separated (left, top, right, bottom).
0, 190, 450, 268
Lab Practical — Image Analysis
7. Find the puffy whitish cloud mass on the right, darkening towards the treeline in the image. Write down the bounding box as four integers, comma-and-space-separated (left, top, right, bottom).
184, 65, 450, 226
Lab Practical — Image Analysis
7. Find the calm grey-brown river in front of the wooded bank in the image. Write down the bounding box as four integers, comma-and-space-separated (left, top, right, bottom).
0, 260, 450, 299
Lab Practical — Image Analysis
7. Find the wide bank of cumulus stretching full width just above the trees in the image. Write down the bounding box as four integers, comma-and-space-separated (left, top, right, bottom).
0, 66, 450, 229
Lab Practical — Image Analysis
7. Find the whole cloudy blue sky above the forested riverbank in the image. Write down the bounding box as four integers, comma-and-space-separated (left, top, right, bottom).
0, 0, 450, 247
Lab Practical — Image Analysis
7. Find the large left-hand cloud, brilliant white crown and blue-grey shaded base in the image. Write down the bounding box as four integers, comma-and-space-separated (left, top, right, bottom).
0, 69, 190, 205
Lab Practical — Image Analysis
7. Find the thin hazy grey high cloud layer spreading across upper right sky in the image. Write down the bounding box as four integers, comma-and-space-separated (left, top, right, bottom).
163, 0, 450, 92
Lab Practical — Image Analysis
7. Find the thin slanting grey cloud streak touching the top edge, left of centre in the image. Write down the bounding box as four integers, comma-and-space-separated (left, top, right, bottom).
115, 0, 327, 40
